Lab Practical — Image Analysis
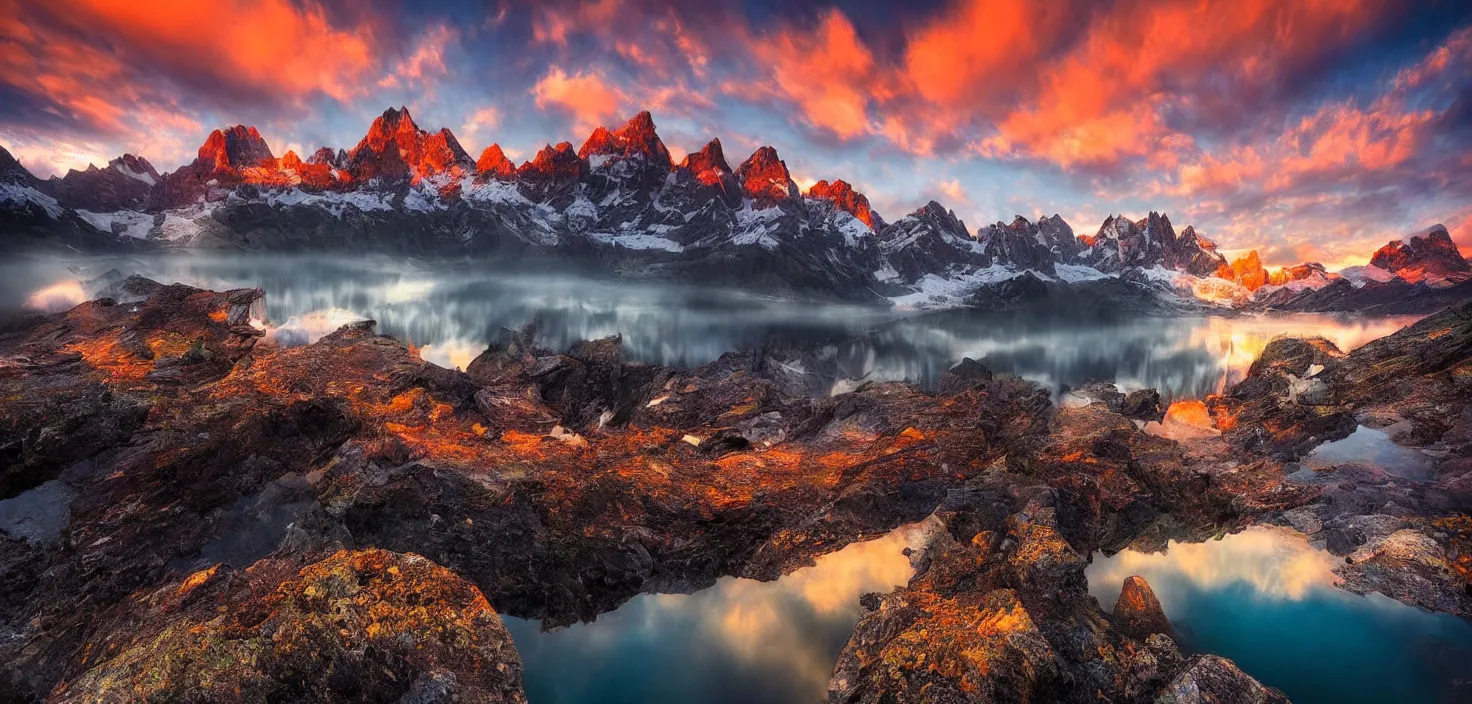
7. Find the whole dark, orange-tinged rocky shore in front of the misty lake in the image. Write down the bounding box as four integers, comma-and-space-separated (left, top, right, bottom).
0, 278, 1472, 703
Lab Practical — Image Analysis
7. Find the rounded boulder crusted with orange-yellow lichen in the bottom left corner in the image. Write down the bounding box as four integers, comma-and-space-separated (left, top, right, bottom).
52, 549, 526, 704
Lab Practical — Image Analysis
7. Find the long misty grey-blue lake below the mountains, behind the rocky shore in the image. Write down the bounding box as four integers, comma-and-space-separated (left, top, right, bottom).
0, 253, 1413, 401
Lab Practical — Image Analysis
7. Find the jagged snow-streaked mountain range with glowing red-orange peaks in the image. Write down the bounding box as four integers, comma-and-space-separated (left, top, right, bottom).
0, 108, 1472, 312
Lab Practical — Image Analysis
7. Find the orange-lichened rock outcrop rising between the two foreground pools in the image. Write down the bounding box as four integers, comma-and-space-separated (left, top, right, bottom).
829, 483, 1287, 704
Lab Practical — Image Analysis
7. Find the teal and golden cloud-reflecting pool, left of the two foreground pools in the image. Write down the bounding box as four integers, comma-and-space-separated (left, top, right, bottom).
505, 524, 927, 704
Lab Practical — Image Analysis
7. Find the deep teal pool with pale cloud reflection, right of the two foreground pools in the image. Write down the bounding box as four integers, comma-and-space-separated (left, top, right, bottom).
1088, 527, 1472, 703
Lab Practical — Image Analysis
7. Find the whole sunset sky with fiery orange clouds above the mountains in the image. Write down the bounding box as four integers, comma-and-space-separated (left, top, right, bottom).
0, 0, 1472, 267
